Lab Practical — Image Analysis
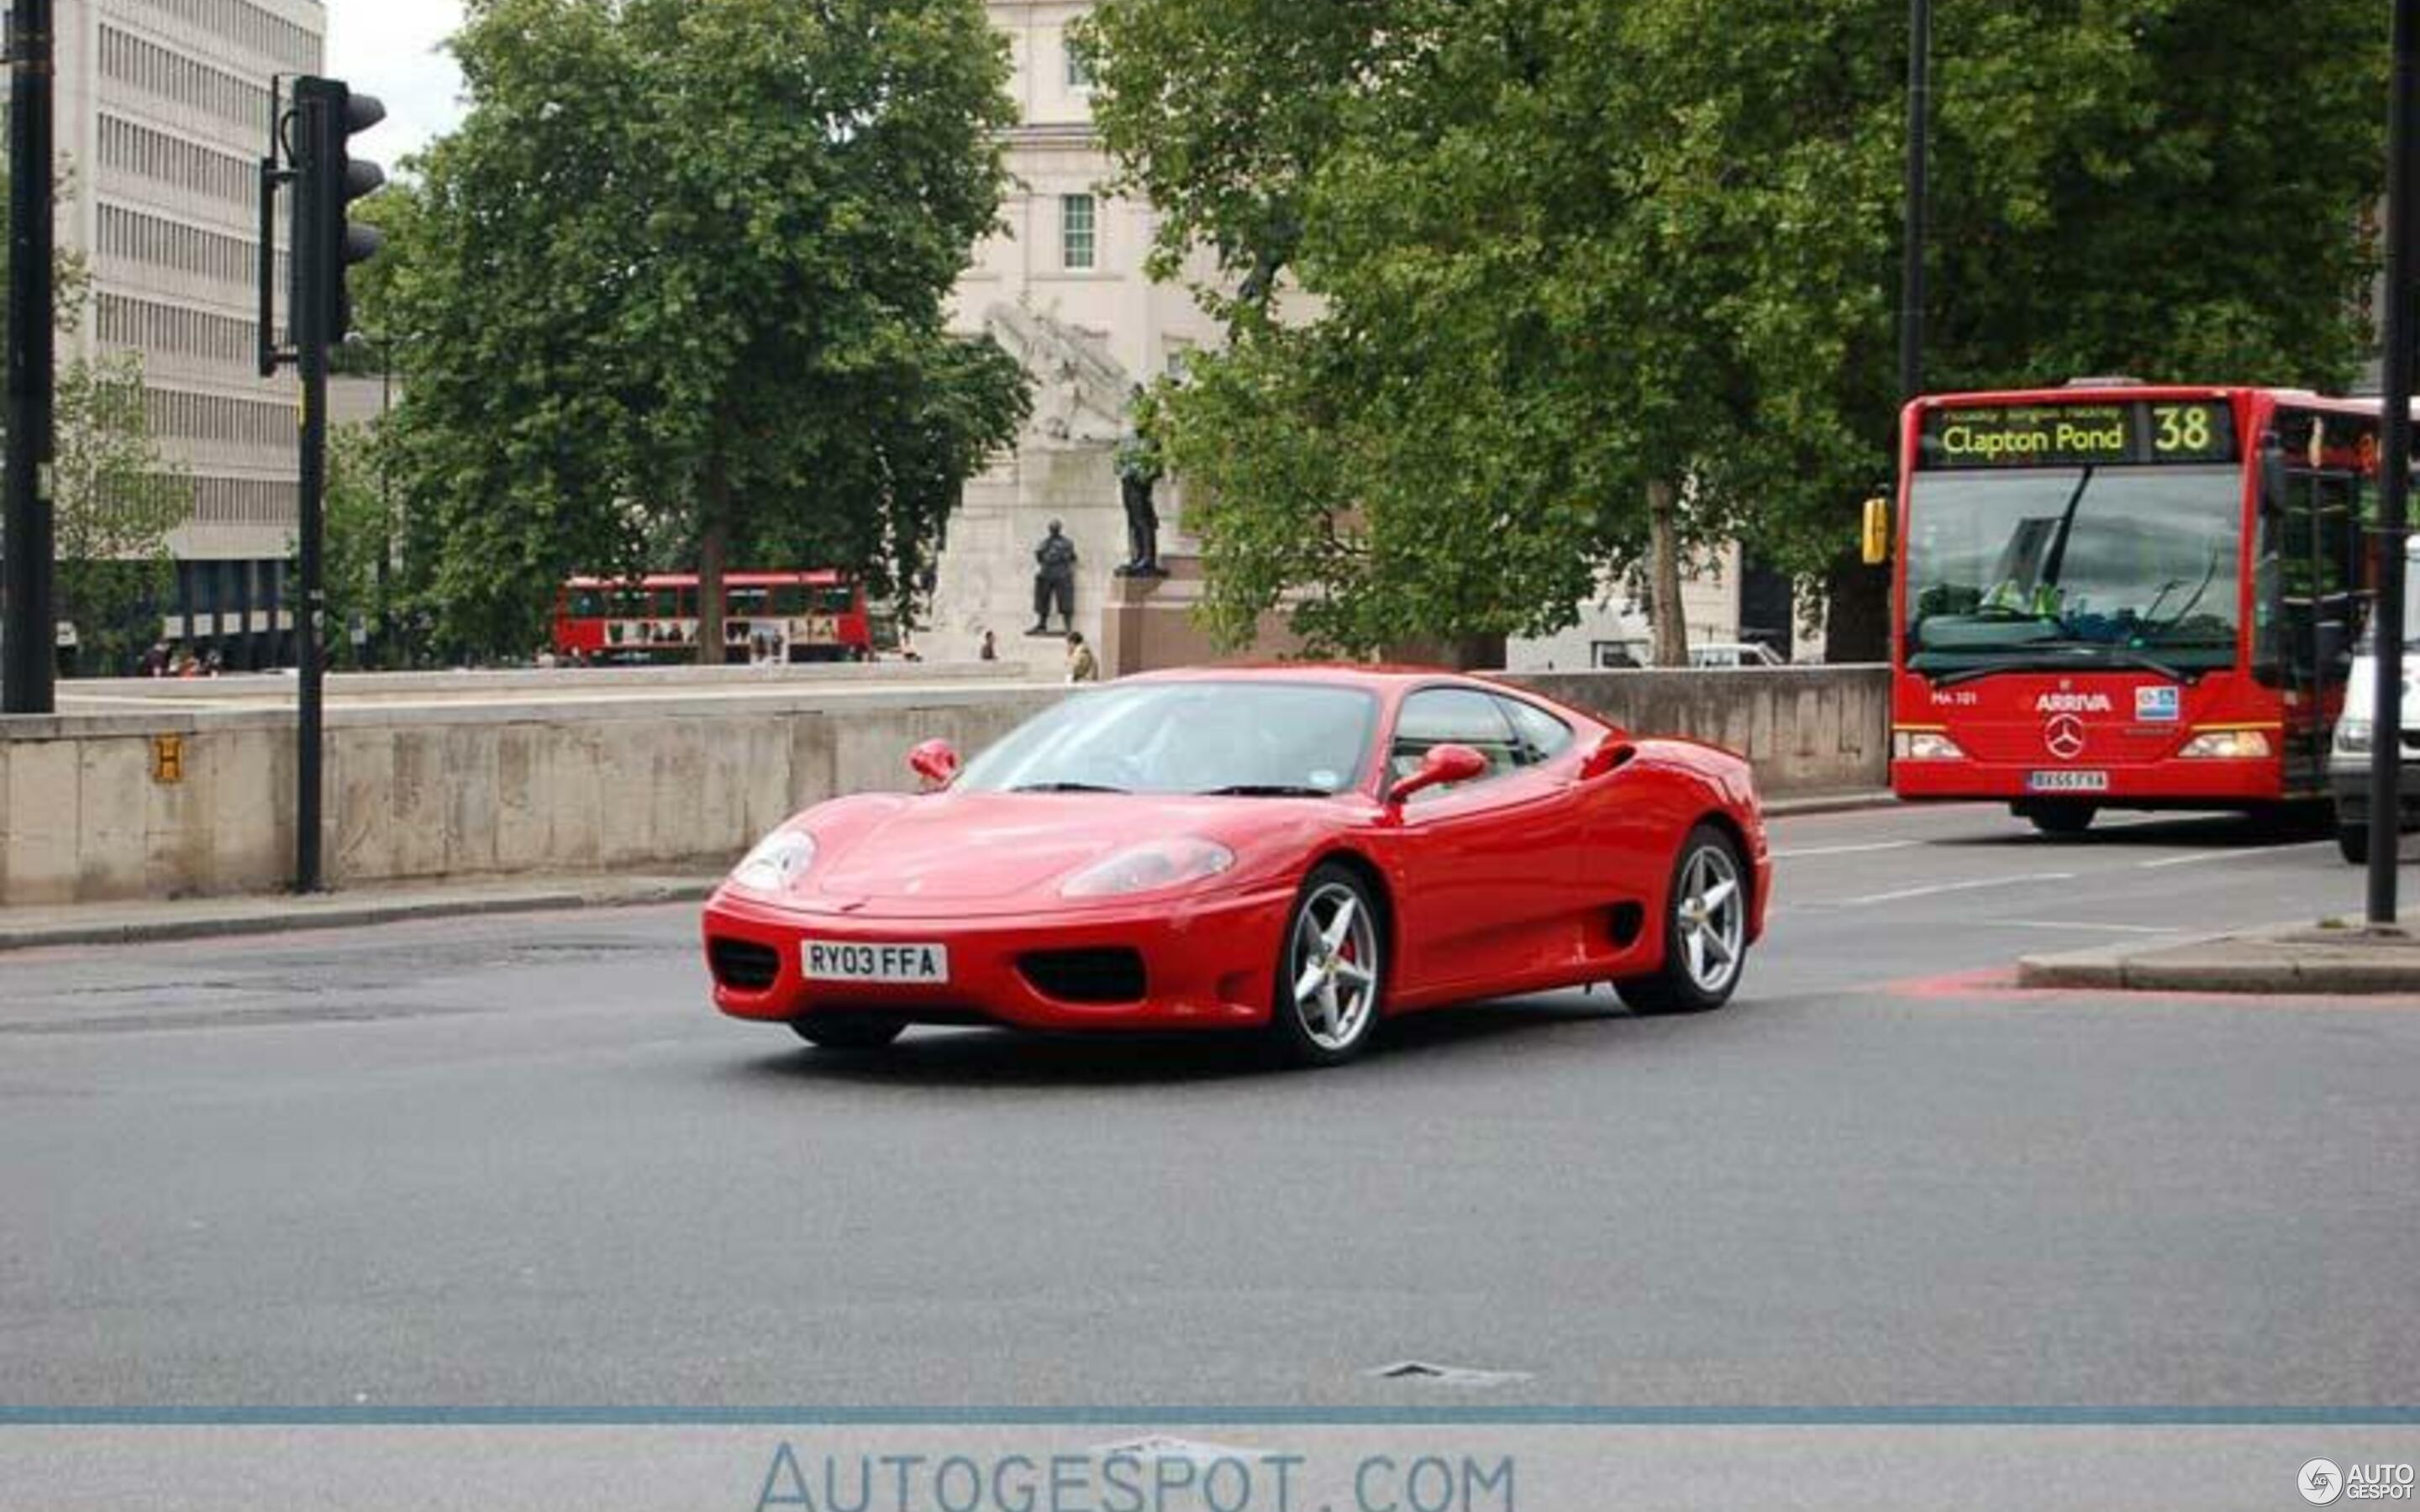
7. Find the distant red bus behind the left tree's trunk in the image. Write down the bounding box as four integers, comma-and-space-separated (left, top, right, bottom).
555, 571, 874, 663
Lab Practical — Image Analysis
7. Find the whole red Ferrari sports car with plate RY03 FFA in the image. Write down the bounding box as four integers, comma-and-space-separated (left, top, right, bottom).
704, 668, 1771, 1064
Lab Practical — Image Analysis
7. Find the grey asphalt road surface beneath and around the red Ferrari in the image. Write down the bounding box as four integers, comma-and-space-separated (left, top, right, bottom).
0, 808, 2420, 1405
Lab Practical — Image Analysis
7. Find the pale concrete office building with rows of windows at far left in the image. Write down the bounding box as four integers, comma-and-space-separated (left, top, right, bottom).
6, 0, 327, 665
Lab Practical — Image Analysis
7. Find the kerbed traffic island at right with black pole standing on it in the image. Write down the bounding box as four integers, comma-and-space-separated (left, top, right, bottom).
2016, 915, 2420, 997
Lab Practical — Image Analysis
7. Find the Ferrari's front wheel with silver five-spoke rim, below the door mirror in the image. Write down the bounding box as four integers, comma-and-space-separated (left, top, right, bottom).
1268, 864, 1386, 1067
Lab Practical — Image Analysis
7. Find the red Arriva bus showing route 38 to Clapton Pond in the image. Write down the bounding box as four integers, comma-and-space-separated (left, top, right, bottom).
1890, 380, 2379, 835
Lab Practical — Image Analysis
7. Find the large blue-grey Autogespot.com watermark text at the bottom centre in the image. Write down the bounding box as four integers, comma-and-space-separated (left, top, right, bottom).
753, 1441, 1518, 1512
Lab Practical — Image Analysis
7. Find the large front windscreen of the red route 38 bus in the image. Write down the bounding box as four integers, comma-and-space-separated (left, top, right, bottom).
1907, 467, 2244, 673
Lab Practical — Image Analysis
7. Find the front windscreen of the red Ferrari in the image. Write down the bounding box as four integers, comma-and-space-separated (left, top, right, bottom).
954, 680, 1377, 798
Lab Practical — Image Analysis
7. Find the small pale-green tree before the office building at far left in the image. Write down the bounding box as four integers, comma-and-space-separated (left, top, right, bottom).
0, 165, 193, 670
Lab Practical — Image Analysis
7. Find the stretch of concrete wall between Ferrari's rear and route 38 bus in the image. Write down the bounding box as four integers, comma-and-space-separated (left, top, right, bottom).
1510, 665, 1890, 798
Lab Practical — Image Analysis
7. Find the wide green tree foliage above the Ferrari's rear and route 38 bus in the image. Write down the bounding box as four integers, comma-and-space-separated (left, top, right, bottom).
1086, 0, 2386, 655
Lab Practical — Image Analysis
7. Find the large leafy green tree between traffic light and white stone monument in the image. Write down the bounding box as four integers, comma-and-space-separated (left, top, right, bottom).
373, 0, 1026, 658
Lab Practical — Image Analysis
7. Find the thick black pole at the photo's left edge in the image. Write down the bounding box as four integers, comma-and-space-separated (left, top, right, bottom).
0, 0, 58, 714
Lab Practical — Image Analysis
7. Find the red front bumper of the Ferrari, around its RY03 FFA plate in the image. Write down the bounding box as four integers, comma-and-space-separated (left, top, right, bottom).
704, 888, 1295, 1028
